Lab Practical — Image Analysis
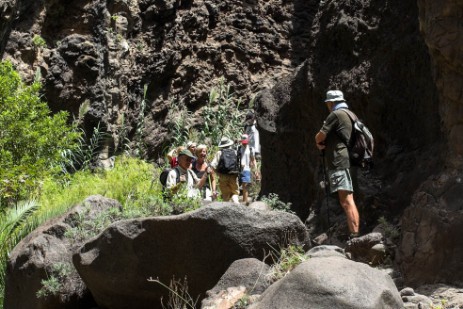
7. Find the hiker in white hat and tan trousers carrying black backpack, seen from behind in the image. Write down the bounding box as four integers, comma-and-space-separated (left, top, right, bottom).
211, 137, 240, 204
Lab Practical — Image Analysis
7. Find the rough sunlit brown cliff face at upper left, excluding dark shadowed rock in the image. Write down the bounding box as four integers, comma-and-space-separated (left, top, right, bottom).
0, 0, 302, 155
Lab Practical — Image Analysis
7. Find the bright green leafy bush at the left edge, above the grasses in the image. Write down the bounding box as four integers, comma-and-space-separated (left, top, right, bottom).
0, 61, 79, 205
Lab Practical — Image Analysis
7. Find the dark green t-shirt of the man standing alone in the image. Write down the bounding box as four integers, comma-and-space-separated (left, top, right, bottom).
320, 109, 352, 170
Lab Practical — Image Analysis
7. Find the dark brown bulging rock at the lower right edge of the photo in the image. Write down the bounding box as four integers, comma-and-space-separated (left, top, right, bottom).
398, 171, 463, 286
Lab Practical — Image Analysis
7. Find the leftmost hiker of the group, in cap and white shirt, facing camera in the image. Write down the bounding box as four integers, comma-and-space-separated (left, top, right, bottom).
166, 149, 212, 198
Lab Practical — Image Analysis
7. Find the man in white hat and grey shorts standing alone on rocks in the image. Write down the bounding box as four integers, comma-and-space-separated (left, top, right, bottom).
315, 90, 360, 238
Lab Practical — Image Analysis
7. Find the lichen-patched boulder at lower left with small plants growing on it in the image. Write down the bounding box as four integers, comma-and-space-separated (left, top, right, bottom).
4, 195, 122, 309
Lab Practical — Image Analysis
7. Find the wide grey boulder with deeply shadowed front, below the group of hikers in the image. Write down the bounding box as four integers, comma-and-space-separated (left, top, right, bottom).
73, 203, 307, 309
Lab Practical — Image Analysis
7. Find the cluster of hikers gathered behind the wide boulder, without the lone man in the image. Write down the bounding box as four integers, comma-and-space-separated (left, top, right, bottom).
161, 112, 261, 204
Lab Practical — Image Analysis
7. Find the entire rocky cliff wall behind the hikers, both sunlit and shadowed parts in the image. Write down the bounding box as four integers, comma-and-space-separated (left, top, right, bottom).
0, 0, 463, 282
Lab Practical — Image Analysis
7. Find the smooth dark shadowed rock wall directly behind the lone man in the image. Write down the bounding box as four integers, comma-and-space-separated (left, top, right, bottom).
256, 1, 443, 221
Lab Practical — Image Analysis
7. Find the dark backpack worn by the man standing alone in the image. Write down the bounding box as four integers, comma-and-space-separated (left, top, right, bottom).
342, 109, 375, 168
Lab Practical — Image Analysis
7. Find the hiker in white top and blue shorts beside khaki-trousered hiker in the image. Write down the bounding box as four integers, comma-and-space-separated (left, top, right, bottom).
238, 134, 260, 205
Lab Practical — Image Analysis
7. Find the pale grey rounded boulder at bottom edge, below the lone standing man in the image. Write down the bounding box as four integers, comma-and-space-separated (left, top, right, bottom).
250, 256, 403, 309
